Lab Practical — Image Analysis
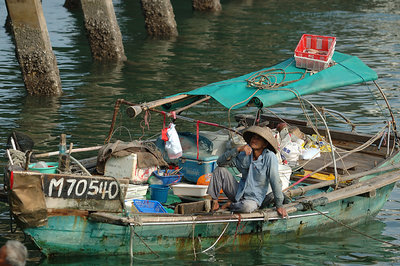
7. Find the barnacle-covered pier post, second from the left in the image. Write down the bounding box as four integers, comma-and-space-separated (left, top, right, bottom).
81, 0, 126, 61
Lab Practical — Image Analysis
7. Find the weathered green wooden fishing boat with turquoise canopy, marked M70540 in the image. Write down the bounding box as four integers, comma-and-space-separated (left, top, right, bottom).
5, 46, 400, 256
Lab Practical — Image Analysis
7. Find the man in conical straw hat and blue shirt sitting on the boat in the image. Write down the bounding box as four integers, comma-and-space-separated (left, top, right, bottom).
207, 126, 287, 217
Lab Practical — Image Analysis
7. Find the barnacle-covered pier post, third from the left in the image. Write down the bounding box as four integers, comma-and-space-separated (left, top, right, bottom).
140, 0, 178, 38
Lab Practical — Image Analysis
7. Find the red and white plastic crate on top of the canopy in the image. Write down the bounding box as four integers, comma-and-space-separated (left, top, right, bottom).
294, 34, 336, 71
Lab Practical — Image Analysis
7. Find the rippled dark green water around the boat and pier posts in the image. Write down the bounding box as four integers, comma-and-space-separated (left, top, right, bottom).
0, 0, 400, 265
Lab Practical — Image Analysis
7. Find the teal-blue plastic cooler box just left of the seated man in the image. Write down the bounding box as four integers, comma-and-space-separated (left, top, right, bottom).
178, 153, 218, 184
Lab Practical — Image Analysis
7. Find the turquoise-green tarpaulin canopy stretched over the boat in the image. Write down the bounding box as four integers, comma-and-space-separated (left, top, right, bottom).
183, 52, 378, 109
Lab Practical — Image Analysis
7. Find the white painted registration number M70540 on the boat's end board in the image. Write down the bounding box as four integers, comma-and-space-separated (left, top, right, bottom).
44, 177, 120, 200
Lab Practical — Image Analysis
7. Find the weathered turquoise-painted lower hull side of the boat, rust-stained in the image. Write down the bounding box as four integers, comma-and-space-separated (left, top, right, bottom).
25, 183, 395, 256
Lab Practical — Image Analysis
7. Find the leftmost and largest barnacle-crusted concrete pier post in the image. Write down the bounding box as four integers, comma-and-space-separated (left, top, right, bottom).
6, 0, 62, 95
